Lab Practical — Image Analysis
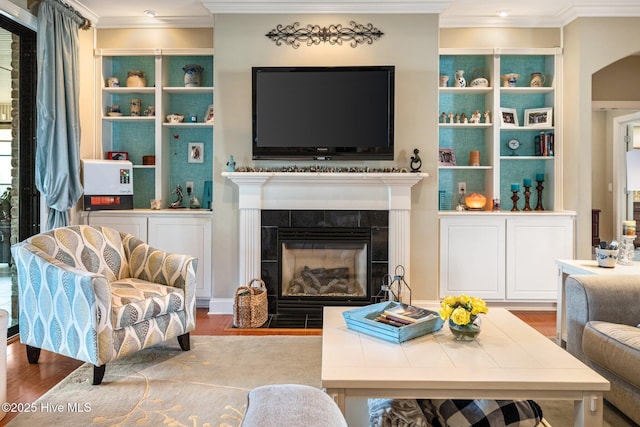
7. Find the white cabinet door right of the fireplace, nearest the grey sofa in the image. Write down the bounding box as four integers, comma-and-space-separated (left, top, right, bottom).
506, 216, 574, 301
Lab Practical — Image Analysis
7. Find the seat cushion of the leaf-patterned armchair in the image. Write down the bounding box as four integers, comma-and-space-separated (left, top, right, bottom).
111, 278, 184, 329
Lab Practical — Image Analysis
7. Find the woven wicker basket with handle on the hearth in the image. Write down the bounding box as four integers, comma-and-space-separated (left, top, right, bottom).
233, 279, 269, 328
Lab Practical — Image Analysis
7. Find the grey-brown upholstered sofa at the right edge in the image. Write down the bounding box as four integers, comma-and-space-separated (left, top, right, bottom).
565, 274, 640, 424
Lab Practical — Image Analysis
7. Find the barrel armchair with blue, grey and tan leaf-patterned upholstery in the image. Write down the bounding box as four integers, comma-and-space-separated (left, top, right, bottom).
11, 225, 197, 385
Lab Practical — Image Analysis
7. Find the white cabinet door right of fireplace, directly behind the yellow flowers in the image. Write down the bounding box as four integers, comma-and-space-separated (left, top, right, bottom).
440, 216, 505, 300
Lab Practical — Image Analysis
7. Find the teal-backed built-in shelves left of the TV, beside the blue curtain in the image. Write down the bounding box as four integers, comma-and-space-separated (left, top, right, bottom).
95, 49, 214, 209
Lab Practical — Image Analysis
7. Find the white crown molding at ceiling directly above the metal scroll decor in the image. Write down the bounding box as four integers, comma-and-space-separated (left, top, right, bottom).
201, 0, 452, 14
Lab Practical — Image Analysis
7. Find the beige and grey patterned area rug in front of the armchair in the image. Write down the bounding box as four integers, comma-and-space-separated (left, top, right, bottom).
8, 335, 322, 427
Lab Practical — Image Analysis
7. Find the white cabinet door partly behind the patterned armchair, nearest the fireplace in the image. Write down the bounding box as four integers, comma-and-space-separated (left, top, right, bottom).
149, 215, 212, 298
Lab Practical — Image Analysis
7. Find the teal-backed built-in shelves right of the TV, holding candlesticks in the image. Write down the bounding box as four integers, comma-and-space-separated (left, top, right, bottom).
438, 48, 562, 211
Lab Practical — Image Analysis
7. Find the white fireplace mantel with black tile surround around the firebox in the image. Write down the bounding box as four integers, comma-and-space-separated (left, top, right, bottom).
220, 170, 429, 325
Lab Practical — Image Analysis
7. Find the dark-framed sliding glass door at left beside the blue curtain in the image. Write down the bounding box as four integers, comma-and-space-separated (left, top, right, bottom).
0, 15, 40, 336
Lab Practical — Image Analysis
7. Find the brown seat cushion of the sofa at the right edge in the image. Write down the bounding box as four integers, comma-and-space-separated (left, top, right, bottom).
582, 320, 640, 387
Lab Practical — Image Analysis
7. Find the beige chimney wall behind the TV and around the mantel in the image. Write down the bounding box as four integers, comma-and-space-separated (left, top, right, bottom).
213, 14, 438, 299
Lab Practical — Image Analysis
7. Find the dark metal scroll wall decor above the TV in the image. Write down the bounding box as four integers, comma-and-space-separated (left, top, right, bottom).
265, 21, 384, 49
